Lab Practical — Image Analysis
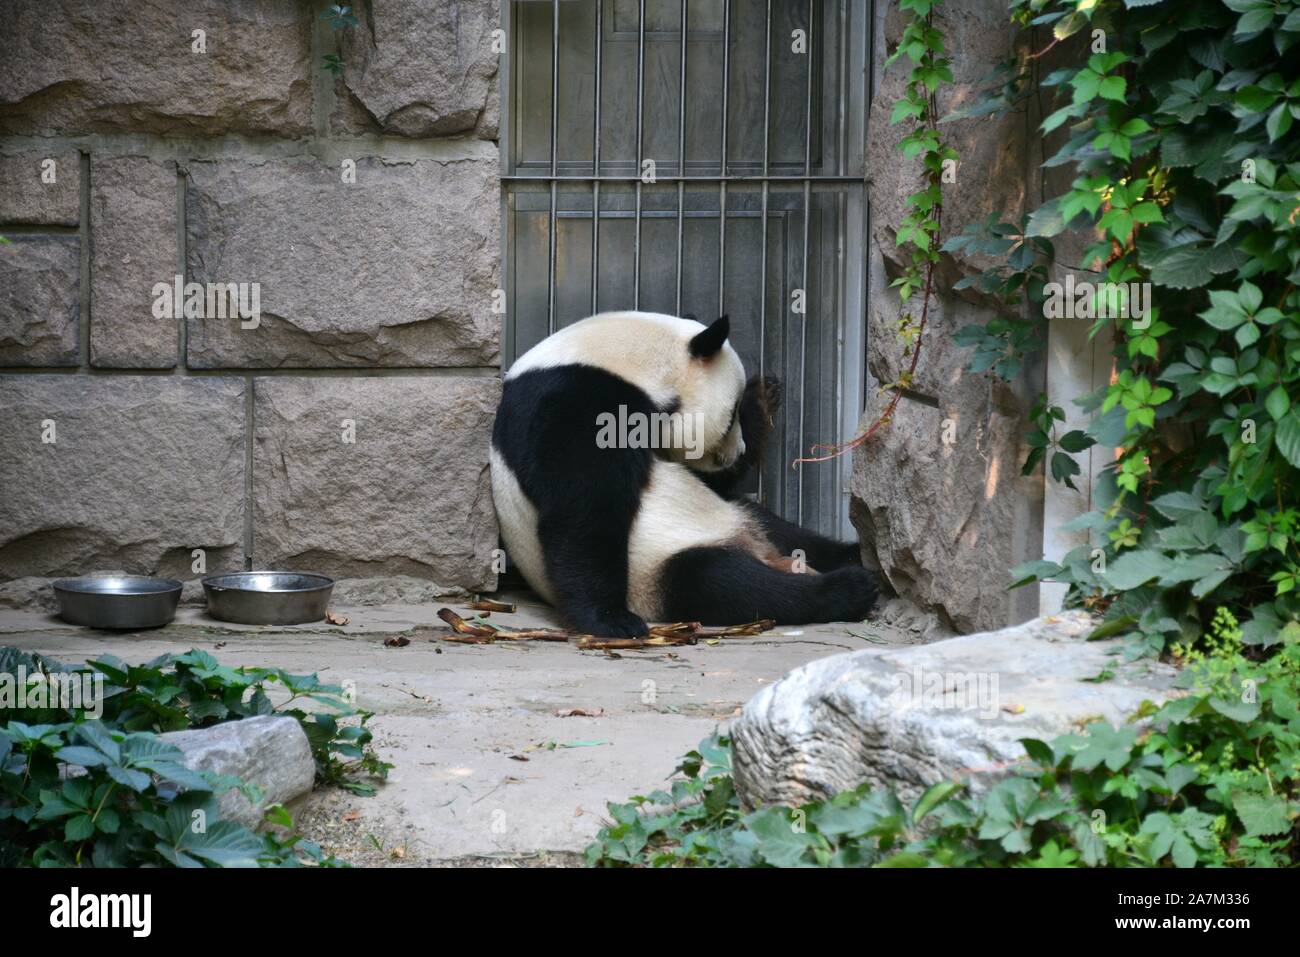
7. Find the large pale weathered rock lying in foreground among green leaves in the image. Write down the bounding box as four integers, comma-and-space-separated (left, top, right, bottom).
731, 611, 1174, 807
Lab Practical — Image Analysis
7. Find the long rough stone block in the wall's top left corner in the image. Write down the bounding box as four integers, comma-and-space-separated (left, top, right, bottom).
0, 0, 315, 137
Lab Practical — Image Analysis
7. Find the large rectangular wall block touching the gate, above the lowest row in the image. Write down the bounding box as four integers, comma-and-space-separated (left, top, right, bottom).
186, 159, 501, 368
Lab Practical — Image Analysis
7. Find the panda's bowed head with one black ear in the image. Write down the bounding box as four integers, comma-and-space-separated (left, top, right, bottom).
673, 316, 745, 472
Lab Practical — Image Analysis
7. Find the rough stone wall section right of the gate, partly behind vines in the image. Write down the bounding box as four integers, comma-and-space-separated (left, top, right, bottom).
850, 0, 1044, 632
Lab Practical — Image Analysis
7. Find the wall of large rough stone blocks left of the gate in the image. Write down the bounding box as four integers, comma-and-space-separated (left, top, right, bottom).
0, 0, 501, 590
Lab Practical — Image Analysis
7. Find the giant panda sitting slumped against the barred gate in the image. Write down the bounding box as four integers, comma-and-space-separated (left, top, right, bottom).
490, 312, 876, 637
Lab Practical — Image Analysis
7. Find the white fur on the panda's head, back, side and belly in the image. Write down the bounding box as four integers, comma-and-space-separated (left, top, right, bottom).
491, 312, 777, 620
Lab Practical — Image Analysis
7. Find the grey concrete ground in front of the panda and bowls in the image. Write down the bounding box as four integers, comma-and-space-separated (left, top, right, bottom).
0, 596, 918, 866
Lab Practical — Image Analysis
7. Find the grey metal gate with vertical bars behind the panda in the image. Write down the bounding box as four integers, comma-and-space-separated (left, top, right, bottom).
502, 0, 871, 536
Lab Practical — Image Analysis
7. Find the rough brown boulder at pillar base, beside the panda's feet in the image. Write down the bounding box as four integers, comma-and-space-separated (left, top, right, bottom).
849, 376, 1043, 632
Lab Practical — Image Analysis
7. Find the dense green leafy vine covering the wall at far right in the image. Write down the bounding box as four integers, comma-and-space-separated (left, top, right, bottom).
946, 0, 1300, 653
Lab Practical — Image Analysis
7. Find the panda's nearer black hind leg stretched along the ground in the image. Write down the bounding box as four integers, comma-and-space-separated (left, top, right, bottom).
660, 546, 878, 624
